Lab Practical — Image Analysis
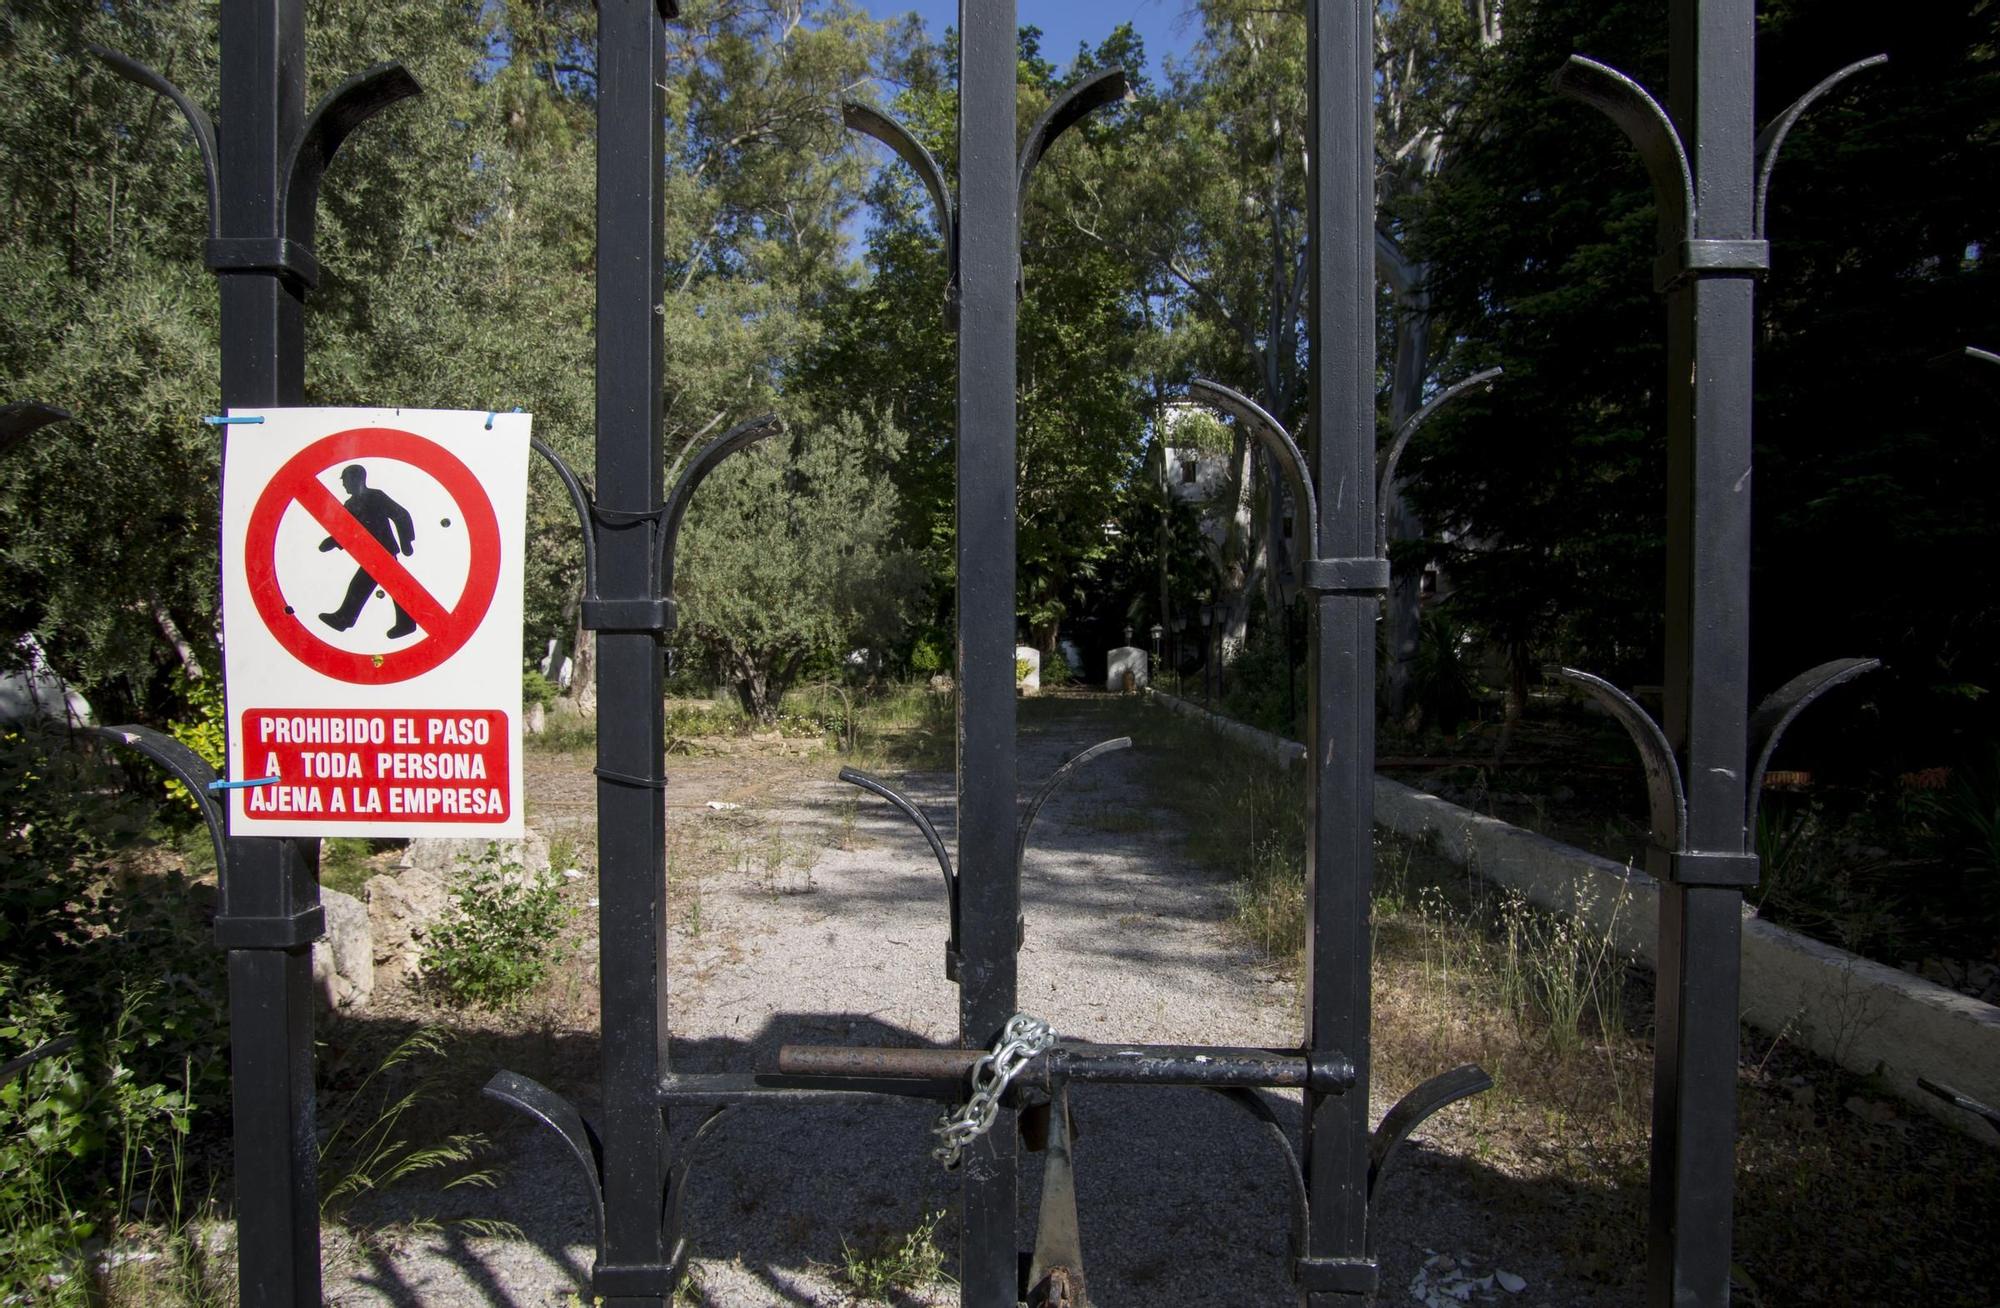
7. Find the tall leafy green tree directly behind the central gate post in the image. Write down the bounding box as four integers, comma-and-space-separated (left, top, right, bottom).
808, 26, 1148, 656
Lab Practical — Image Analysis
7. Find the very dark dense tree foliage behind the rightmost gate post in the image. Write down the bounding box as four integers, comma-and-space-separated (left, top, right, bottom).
1384, 0, 2000, 764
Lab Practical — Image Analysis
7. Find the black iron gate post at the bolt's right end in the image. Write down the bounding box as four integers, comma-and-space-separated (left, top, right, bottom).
1298, 0, 1388, 1308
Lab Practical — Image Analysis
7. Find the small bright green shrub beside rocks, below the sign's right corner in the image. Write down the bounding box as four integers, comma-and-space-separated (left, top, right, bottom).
422, 846, 572, 1008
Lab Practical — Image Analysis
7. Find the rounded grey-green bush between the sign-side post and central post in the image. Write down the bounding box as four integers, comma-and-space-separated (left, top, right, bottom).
676, 414, 920, 724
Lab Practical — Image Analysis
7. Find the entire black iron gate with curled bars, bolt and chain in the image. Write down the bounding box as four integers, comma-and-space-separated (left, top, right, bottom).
66, 0, 1872, 1308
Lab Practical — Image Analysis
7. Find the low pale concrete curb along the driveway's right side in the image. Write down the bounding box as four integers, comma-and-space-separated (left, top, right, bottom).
1152, 690, 2000, 1144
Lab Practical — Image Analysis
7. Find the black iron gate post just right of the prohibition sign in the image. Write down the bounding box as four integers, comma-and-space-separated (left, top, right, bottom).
586, 0, 684, 1308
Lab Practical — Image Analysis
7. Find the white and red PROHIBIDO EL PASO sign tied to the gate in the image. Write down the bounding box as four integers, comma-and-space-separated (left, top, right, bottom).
222, 408, 530, 836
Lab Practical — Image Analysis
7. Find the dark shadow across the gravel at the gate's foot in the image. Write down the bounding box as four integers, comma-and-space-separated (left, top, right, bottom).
332, 1014, 1630, 1308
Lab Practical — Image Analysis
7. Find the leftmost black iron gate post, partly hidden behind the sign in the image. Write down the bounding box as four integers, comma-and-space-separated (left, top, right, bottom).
92, 0, 420, 1308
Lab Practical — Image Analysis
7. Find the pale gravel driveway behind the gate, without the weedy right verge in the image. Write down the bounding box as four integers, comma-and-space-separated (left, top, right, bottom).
328, 700, 1616, 1308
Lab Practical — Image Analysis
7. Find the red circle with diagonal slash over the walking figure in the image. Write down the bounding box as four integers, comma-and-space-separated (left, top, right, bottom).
244, 426, 500, 686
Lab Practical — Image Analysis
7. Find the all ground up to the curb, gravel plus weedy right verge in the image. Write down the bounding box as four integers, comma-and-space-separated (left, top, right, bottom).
326, 696, 2000, 1308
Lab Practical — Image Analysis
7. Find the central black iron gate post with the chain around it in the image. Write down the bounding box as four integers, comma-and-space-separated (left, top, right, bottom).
956, 0, 1020, 1308
